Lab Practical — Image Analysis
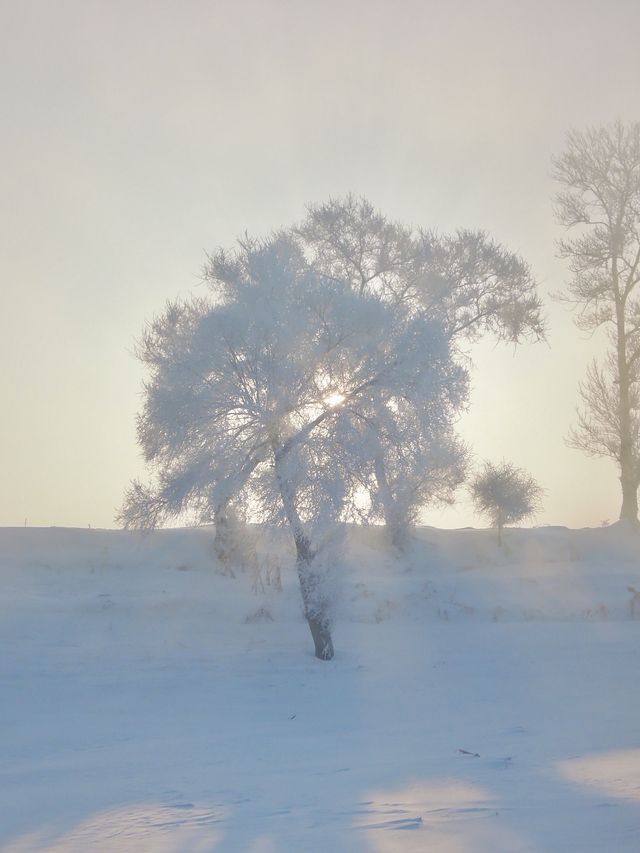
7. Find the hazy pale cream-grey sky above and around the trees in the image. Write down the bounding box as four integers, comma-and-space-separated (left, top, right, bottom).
0, 0, 640, 527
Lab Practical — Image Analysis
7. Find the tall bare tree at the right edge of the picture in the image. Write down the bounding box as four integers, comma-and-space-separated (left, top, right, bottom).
553, 122, 640, 525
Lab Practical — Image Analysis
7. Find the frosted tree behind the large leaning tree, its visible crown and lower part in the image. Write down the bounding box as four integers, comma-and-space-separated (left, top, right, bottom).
295, 195, 544, 549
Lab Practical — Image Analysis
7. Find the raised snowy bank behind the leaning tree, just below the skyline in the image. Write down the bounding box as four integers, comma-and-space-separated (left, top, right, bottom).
0, 525, 640, 622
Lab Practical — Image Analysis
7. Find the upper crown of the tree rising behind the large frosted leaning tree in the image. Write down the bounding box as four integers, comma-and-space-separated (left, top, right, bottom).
295, 195, 545, 347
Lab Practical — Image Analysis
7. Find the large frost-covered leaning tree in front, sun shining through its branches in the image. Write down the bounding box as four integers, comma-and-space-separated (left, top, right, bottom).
121, 235, 466, 659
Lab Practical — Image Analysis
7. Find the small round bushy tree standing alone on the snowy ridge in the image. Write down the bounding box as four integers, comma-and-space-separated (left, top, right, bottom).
469, 462, 543, 545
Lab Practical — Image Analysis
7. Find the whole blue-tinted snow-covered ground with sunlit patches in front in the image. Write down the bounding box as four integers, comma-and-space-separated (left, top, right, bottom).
0, 527, 640, 853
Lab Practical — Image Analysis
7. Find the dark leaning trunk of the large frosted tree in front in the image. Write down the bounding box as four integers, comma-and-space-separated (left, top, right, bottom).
274, 451, 333, 660
